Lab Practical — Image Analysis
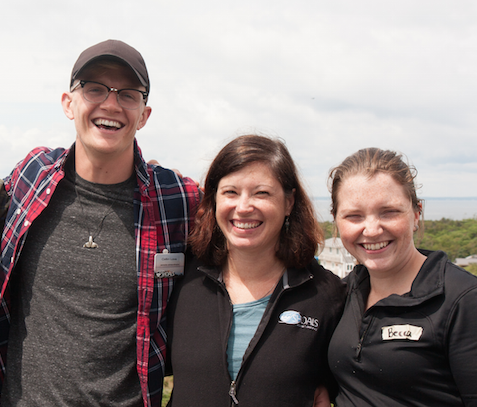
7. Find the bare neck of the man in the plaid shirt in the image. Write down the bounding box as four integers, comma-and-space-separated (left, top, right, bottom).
75, 143, 134, 184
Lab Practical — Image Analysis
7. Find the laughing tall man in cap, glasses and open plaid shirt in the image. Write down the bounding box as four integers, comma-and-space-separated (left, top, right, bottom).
0, 40, 199, 407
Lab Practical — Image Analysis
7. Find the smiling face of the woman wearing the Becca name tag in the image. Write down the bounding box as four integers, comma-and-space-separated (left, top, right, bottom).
335, 173, 419, 273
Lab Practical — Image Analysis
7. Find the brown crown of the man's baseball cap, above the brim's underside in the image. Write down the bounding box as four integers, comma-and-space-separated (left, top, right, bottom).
70, 40, 149, 93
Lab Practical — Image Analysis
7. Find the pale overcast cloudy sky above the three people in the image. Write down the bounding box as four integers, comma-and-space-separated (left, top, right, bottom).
0, 0, 477, 197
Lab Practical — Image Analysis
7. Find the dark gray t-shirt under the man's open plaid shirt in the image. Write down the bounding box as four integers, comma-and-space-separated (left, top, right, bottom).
2, 160, 143, 407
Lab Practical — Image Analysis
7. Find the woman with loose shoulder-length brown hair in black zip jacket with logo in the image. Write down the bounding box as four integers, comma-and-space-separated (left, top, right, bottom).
168, 135, 345, 407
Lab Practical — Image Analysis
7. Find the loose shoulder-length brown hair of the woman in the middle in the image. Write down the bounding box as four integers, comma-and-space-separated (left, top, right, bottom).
189, 134, 323, 268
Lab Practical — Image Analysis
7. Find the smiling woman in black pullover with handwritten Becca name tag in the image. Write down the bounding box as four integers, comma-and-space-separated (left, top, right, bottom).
329, 148, 477, 407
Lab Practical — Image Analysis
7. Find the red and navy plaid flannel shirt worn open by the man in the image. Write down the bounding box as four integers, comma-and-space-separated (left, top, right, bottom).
0, 142, 200, 407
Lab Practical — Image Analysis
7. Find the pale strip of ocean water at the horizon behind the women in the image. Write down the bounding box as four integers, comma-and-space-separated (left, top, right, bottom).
313, 197, 477, 221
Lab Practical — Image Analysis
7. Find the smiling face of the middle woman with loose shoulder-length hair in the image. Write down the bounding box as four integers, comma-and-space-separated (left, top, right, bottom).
215, 162, 294, 255
